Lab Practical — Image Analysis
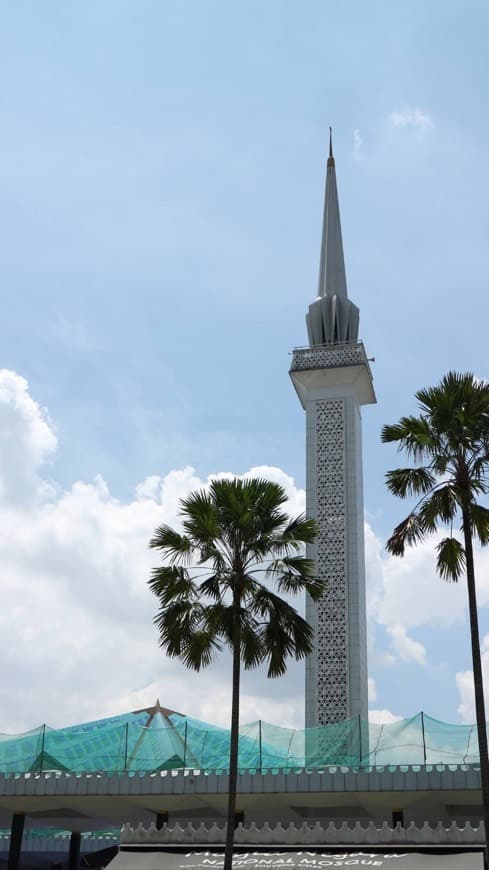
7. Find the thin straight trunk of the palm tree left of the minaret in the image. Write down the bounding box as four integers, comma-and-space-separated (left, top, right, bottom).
223, 589, 241, 870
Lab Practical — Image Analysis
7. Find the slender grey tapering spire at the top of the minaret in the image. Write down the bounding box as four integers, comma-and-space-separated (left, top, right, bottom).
318, 127, 348, 299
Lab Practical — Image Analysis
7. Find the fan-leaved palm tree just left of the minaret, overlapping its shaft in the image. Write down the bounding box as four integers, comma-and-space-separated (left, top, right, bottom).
149, 478, 324, 870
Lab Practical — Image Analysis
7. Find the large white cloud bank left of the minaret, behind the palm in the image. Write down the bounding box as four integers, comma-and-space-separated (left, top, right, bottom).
0, 371, 305, 731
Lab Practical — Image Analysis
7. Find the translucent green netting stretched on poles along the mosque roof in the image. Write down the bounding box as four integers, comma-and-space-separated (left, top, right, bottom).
0, 711, 479, 773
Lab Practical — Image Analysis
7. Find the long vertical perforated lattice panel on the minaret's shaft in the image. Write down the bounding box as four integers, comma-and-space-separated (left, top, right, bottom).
316, 399, 349, 725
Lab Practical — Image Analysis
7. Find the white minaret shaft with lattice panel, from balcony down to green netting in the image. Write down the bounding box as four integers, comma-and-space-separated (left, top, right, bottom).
291, 346, 375, 728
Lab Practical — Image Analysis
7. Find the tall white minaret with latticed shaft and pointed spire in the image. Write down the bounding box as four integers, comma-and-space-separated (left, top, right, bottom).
290, 129, 376, 728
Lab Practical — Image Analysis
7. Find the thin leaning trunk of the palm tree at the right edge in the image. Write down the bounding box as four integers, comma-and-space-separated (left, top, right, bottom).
462, 507, 489, 870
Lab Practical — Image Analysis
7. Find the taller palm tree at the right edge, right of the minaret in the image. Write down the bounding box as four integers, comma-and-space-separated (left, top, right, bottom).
382, 372, 489, 867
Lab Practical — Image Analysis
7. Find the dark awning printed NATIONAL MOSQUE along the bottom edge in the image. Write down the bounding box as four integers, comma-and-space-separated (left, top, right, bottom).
109, 846, 483, 870
